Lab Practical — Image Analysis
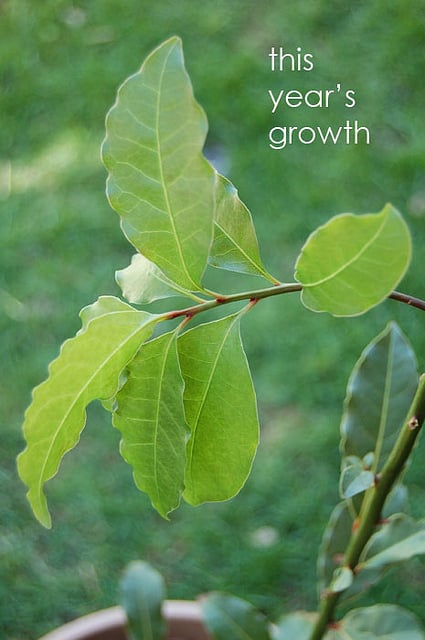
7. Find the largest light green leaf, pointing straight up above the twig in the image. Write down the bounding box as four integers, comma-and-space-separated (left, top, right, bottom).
103, 37, 215, 290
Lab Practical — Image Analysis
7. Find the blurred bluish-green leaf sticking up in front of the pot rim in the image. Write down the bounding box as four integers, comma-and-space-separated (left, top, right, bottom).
120, 561, 167, 640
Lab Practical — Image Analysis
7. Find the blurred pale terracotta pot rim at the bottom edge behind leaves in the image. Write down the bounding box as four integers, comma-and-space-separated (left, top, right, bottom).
39, 600, 202, 640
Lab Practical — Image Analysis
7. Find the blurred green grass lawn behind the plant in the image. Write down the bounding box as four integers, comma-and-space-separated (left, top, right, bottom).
0, 0, 425, 640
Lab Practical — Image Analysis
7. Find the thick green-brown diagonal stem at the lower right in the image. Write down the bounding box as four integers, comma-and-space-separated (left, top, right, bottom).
310, 374, 425, 640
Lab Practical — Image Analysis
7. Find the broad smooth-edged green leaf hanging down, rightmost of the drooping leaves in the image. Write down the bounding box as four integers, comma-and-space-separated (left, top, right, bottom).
178, 315, 259, 504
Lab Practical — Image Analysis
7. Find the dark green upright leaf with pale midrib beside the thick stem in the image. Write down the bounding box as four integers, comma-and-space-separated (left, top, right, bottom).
341, 323, 418, 473
